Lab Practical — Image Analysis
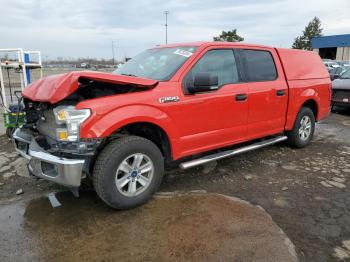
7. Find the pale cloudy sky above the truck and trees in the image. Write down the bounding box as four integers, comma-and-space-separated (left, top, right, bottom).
0, 0, 350, 59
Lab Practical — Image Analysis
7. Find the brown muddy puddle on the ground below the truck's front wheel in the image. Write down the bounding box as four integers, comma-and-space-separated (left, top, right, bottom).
0, 192, 297, 262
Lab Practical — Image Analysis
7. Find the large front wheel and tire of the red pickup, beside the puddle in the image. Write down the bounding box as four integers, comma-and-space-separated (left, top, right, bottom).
92, 136, 164, 209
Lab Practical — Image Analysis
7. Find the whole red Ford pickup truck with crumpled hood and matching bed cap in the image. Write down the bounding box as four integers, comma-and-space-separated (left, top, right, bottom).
13, 42, 331, 209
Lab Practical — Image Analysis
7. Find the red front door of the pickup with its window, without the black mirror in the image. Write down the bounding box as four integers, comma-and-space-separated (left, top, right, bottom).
176, 49, 248, 155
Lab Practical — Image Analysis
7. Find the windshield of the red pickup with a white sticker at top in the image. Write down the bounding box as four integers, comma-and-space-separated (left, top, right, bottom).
113, 46, 197, 81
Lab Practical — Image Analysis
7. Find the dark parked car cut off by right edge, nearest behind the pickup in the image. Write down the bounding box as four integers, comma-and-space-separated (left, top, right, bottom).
332, 69, 350, 108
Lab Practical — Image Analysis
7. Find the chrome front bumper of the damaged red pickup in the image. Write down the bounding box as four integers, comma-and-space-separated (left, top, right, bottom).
13, 128, 85, 187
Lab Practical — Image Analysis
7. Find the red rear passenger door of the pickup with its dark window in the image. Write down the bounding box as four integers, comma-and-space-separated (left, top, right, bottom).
238, 49, 288, 139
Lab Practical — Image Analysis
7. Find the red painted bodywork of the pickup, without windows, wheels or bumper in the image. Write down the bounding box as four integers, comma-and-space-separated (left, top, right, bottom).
23, 42, 331, 159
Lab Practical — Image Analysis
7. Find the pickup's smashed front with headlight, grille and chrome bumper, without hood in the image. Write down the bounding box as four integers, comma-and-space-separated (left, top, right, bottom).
12, 98, 103, 187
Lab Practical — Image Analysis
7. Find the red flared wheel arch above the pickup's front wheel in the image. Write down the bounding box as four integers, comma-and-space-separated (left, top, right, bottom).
80, 105, 179, 157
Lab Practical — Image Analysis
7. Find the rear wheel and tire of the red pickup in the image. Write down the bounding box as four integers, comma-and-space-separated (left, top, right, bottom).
287, 107, 315, 148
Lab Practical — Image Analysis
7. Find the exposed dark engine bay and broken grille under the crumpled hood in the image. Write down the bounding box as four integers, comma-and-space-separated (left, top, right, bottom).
19, 77, 147, 158
